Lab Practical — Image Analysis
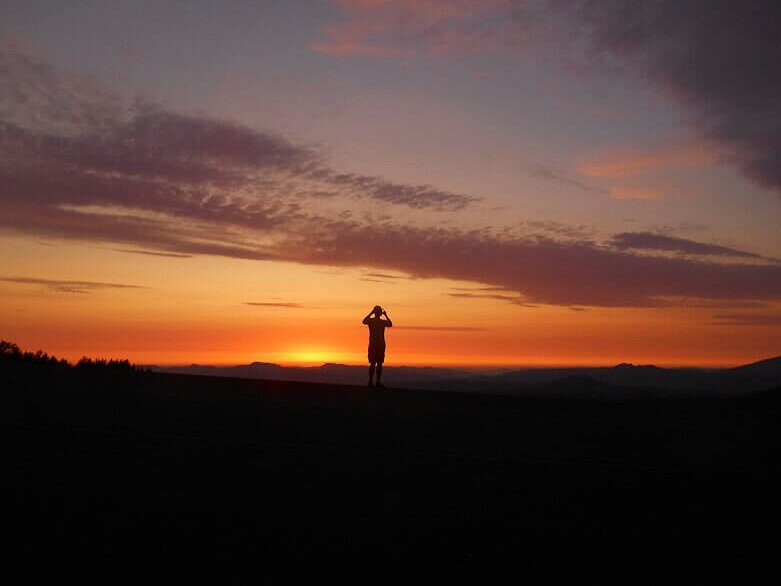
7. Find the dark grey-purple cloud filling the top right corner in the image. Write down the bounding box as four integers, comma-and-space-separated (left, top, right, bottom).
551, 0, 781, 193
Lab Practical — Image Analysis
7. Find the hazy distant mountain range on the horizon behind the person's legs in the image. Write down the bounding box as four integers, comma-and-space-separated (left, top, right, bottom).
147, 356, 781, 395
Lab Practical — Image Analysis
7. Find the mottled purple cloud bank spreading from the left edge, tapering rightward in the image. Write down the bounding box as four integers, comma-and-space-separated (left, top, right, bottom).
0, 43, 475, 213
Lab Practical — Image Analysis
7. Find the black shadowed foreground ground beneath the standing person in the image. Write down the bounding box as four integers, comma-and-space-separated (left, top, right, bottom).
0, 373, 781, 584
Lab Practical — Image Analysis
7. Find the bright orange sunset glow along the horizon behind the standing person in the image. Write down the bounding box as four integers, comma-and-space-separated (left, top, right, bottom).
0, 238, 781, 367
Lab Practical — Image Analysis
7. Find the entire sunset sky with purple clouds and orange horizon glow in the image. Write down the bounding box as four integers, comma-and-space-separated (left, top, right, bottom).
0, 0, 781, 367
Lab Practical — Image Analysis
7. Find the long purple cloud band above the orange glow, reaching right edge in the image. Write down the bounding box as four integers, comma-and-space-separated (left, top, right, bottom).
285, 224, 781, 306
